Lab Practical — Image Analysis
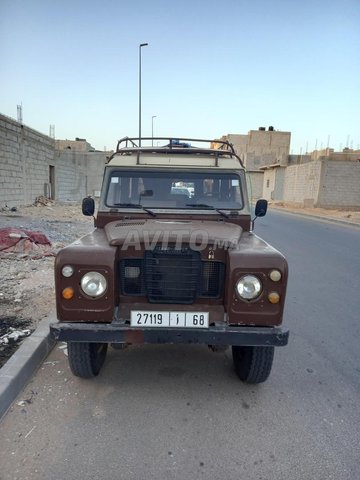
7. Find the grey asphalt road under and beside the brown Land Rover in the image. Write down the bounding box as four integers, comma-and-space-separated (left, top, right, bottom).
0, 212, 360, 480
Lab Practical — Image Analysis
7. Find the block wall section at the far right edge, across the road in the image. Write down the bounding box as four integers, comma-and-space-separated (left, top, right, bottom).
317, 159, 360, 208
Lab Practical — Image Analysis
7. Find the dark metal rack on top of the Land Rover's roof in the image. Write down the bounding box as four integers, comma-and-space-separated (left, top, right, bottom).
109, 137, 244, 167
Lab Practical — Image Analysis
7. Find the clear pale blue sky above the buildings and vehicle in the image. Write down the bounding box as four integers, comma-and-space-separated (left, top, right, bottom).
0, 0, 360, 153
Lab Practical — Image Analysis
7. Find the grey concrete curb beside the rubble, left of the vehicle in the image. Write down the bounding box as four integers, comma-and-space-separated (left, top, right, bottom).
0, 312, 56, 418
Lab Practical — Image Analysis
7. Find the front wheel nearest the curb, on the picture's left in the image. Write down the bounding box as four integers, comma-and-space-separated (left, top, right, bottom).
68, 342, 107, 378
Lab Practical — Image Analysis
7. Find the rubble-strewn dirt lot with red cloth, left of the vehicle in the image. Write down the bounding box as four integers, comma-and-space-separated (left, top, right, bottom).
0, 202, 93, 368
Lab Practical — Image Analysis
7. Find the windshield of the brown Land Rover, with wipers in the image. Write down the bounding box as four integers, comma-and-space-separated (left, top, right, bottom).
105, 170, 243, 210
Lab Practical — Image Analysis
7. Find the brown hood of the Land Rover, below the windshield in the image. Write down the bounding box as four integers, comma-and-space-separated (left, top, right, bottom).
105, 219, 242, 249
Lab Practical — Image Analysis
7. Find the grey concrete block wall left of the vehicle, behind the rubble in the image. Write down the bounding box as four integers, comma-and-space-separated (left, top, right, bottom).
0, 114, 107, 208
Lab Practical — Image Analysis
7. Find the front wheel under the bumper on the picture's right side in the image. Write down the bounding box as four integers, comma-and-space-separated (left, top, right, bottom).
232, 345, 274, 383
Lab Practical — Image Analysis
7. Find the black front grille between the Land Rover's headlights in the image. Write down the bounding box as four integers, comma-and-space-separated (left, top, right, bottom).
120, 247, 225, 304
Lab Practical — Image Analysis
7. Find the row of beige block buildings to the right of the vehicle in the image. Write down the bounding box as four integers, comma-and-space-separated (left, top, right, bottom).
212, 127, 360, 209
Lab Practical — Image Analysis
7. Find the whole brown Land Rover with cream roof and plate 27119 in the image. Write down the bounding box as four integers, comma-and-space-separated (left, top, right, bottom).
50, 138, 289, 383
